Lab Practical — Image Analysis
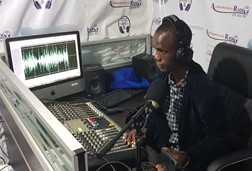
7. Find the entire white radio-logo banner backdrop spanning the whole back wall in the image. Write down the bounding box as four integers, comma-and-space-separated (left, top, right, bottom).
0, 0, 252, 71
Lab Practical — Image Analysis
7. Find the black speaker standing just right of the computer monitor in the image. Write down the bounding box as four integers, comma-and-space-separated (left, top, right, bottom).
83, 64, 105, 96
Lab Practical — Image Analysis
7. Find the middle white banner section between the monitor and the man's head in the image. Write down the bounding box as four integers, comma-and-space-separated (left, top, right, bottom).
85, 0, 153, 41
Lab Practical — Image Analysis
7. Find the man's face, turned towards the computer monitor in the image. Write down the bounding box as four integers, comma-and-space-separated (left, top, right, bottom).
152, 31, 179, 72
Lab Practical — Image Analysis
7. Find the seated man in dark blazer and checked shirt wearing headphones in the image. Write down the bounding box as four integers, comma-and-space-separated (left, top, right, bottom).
125, 15, 226, 171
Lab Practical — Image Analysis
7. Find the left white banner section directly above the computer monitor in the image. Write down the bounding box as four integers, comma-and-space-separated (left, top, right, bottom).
0, 0, 87, 53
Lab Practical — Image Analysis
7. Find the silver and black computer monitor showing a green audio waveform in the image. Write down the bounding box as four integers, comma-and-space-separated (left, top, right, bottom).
5, 31, 84, 99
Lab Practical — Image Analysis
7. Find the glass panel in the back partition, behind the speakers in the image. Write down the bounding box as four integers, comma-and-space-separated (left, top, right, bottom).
81, 38, 146, 67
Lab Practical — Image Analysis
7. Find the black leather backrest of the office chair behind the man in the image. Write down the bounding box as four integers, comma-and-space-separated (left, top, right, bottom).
208, 42, 252, 148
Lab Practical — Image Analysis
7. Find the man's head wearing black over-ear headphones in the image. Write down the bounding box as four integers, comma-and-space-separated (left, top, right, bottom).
153, 15, 193, 72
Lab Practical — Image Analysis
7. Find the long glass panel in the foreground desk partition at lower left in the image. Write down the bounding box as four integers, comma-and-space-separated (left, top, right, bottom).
0, 65, 74, 171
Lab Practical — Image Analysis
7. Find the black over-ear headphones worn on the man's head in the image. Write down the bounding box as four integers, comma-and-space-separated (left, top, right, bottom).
162, 15, 193, 64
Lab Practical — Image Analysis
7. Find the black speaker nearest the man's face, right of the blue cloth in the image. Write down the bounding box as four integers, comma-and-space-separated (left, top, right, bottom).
132, 53, 157, 82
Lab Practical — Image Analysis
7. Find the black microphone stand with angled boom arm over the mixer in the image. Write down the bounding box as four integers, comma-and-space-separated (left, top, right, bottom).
96, 101, 151, 171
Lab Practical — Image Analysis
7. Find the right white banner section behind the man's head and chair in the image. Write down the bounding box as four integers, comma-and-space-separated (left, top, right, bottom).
151, 0, 252, 71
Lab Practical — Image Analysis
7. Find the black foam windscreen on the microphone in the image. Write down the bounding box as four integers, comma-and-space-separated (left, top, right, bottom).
145, 79, 169, 105
